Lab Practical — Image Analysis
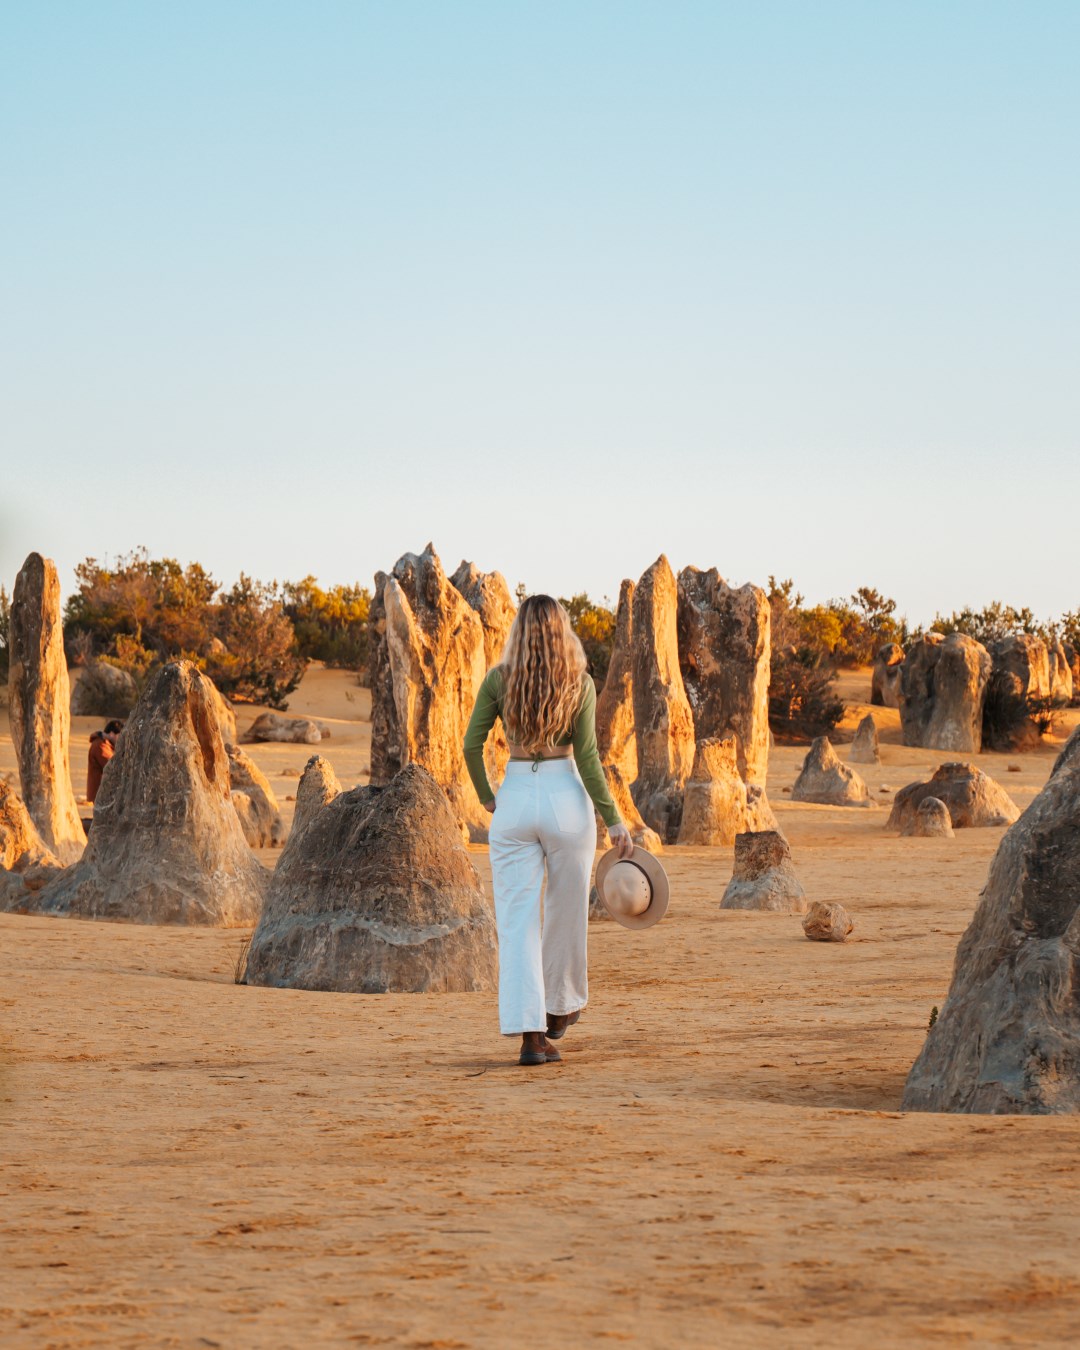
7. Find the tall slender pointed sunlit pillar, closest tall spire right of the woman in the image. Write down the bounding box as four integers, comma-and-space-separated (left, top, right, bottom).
632, 555, 694, 844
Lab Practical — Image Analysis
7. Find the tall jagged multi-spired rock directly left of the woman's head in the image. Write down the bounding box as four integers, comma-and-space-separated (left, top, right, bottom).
370, 544, 490, 844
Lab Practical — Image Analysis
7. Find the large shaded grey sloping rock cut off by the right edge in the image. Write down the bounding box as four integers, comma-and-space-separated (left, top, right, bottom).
900, 732, 1080, 1115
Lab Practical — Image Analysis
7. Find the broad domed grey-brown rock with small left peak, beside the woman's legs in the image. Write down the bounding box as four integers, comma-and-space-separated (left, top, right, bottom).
246, 757, 497, 994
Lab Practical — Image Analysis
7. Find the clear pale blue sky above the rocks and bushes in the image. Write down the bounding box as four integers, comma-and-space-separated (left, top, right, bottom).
0, 0, 1080, 620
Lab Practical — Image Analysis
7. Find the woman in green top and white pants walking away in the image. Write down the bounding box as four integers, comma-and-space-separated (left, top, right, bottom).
464, 595, 633, 1064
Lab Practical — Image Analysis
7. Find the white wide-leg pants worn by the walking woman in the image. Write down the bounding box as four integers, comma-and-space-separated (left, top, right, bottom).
489, 759, 597, 1035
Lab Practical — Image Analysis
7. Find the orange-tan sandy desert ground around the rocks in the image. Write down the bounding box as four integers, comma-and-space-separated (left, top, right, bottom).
0, 668, 1080, 1350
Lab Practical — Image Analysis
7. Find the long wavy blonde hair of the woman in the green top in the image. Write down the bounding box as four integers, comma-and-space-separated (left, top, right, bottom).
500, 595, 587, 755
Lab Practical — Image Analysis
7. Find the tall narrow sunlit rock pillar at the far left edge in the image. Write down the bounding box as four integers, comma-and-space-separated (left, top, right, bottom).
8, 554, 86, 863
